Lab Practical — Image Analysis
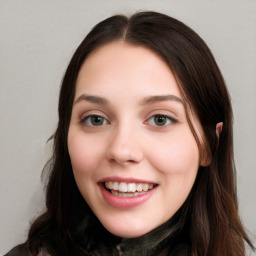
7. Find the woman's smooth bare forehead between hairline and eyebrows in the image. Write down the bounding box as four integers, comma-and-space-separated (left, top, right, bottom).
76, 41, 180, 96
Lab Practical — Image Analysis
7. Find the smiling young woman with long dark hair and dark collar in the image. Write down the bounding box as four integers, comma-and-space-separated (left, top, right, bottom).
7, 12, 253, 256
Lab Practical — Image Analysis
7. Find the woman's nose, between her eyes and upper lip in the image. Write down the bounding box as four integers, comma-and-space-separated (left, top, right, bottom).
107, 125, 143, 165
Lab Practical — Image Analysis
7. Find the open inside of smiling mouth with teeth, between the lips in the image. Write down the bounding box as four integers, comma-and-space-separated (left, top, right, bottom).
104, 181, 157, 197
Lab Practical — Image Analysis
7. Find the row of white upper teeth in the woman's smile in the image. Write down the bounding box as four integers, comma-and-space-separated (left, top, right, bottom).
105, 181, 153, 192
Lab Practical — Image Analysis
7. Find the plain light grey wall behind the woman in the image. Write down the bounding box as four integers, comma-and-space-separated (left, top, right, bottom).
0, 0, 256, 254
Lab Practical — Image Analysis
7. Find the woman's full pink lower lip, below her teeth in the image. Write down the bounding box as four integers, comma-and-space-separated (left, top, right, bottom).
99, 183, 157, 209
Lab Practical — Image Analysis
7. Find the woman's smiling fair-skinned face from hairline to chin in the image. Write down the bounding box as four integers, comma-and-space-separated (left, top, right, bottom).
68, 42, 207, 238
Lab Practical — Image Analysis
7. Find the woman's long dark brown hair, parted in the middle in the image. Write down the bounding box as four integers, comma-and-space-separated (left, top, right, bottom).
27, 12, 253, 256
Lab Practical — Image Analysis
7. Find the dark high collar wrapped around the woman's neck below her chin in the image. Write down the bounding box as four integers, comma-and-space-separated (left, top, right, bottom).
84, 206, 188, 256
